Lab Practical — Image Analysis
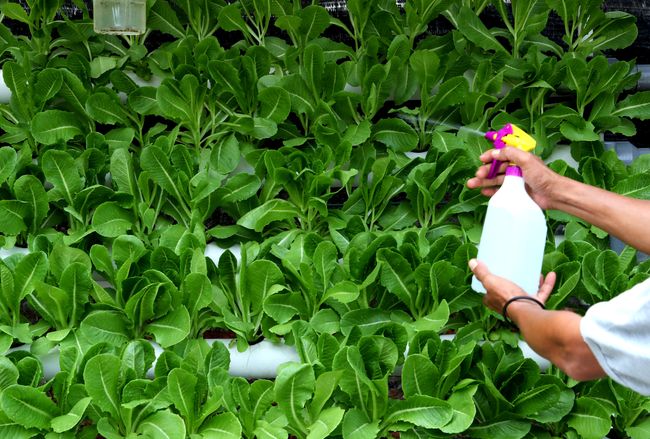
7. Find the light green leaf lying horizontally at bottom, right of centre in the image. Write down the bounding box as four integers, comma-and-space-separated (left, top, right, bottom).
384, 395, 453, 428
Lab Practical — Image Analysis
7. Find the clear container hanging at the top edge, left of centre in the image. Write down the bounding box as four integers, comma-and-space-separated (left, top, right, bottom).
93, 0, 147, 35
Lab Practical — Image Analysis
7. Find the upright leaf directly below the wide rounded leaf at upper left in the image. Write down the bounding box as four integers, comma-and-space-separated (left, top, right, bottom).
41, 149, 83, 205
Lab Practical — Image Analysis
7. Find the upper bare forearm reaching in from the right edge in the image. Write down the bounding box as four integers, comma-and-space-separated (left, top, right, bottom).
549, 177, 650, 253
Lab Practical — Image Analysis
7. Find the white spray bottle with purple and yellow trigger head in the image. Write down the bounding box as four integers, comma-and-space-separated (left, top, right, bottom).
472, 124, 546, 295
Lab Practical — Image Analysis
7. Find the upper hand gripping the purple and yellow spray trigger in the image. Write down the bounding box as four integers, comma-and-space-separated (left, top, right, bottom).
467, 146, 563, 209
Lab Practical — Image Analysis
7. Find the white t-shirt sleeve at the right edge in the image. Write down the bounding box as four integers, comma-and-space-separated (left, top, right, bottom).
580, 279, 650, 395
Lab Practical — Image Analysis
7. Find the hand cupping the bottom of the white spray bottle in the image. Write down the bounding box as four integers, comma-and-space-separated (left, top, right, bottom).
469, 259, 557, 314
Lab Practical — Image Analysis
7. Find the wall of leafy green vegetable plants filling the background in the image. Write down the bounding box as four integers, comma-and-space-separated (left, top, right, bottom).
0, 0, 650, 439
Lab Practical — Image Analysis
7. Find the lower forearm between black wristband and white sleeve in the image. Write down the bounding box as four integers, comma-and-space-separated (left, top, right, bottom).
508, 301, 605, 380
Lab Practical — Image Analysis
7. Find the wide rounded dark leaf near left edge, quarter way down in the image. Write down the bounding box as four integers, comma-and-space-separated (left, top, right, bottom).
32, 110, 83, 145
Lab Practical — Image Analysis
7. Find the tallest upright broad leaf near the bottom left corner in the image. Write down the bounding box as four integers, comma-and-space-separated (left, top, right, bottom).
83, 354, 121, 418
